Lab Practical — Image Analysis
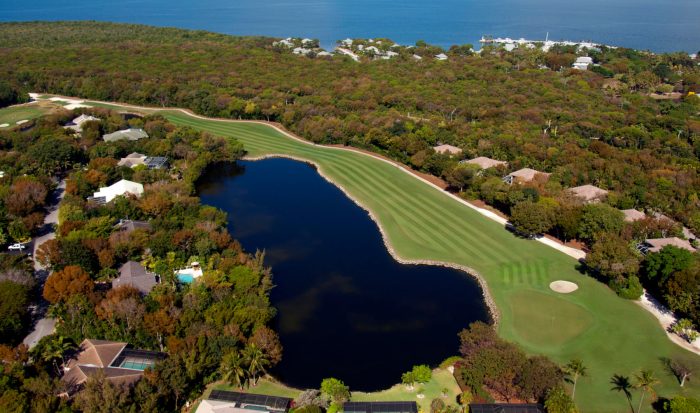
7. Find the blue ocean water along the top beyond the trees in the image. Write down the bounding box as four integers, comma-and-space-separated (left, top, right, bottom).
0, 0, 700, 53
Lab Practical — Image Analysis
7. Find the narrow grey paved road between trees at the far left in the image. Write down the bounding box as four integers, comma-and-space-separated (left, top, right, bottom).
22, 180, 66, 349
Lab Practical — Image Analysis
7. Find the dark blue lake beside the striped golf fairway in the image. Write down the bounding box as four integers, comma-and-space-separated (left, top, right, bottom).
198, 159, 488, 390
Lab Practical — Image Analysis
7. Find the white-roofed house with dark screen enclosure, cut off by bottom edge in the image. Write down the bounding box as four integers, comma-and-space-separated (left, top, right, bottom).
195, 390, 292, 413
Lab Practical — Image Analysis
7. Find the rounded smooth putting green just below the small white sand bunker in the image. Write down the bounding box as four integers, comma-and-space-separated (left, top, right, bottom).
509, 290, 593, 348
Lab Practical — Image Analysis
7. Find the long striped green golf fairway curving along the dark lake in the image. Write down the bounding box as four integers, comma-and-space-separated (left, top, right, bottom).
74, 100, 700, 412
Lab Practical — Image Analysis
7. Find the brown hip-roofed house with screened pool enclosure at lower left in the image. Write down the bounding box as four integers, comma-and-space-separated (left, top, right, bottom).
61, 339, 166, 396
